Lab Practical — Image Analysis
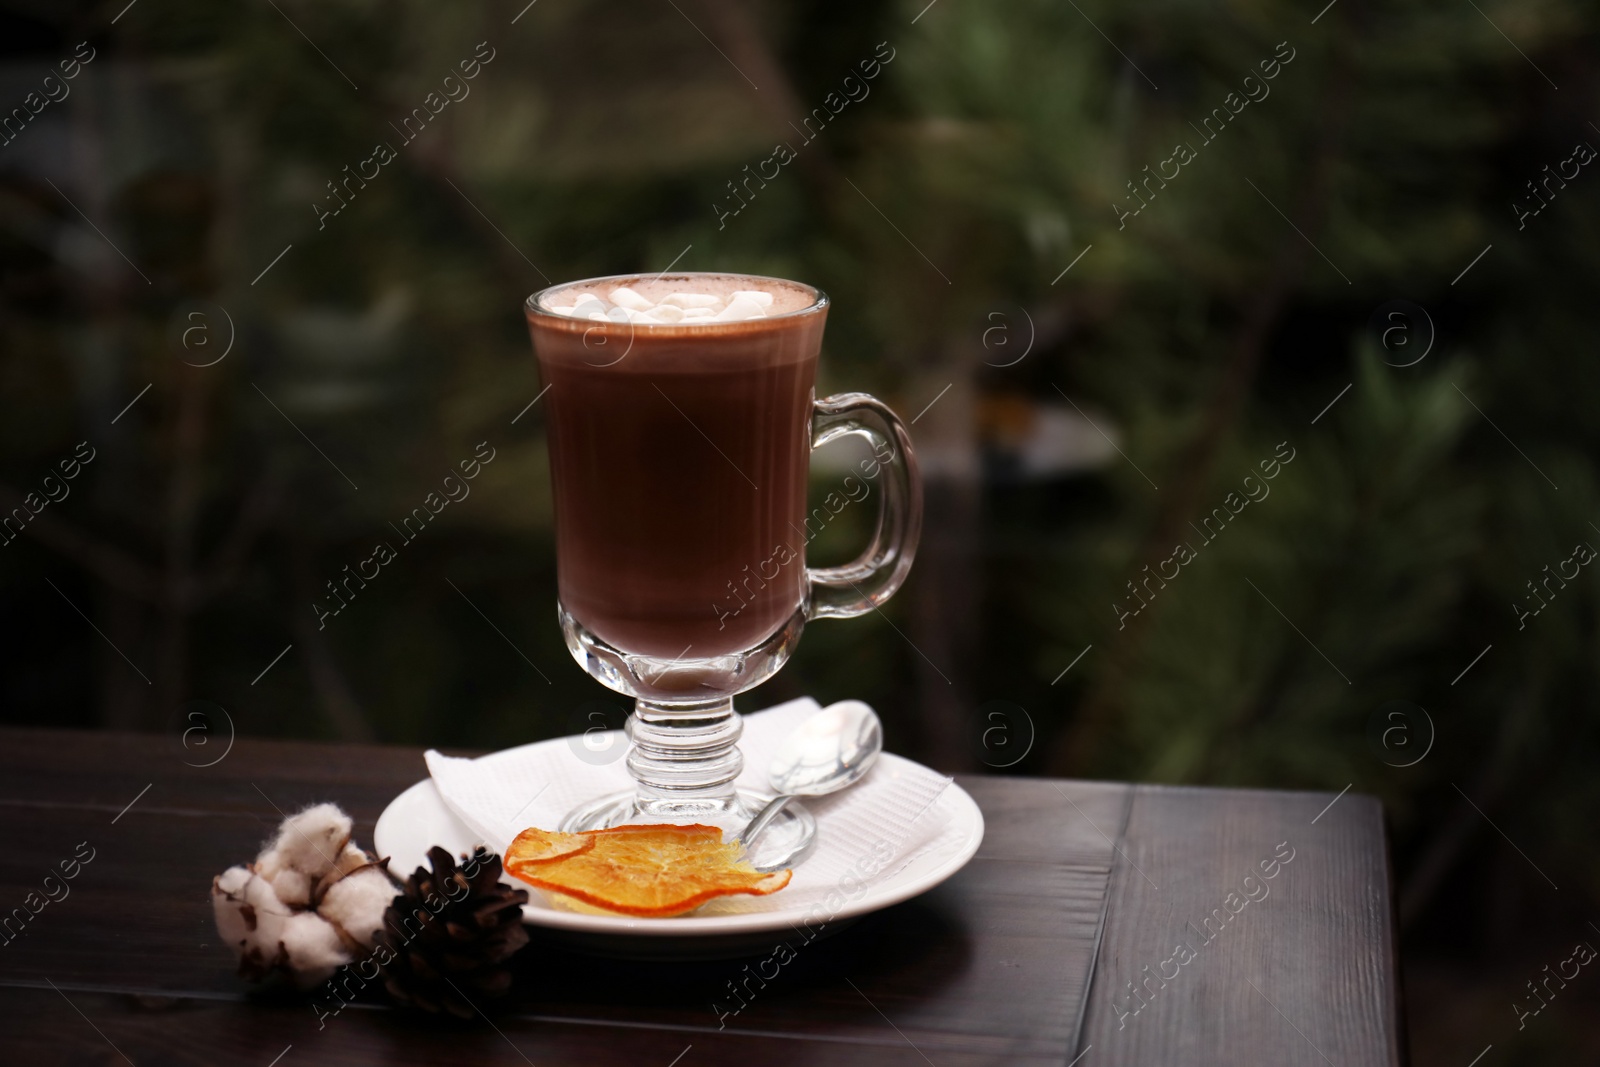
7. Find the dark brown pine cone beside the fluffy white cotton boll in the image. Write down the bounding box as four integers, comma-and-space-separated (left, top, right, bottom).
378, 846, 528, 1019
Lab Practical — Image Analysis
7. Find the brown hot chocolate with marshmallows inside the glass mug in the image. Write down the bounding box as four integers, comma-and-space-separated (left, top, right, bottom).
528, 275, 827, 659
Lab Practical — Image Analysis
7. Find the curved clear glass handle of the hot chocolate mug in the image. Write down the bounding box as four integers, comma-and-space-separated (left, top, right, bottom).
806, 392, 922, 619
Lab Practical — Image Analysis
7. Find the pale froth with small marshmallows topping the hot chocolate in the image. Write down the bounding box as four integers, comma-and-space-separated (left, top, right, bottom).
539, 274, 818, 326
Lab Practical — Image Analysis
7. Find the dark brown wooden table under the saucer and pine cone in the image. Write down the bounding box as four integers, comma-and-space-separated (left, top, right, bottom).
0, 729, 1403, 1067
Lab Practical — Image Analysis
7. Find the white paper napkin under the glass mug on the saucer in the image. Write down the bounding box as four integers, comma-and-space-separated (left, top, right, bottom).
426, 697, 950, 915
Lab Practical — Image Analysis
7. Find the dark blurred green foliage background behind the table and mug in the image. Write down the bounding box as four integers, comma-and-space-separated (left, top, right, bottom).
0, 0, 1600, 1065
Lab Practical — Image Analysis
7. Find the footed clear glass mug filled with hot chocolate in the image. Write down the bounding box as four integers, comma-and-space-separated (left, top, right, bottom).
525, 272, 922, 867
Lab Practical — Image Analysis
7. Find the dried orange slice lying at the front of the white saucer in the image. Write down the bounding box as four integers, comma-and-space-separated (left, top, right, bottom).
506, 824, 794, 917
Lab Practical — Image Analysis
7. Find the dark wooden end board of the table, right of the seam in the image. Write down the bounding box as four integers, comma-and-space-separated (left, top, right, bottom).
1082, 787, 1400, 1067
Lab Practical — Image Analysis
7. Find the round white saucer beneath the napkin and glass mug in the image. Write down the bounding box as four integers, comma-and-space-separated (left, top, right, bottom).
373, 737, 984, 958
